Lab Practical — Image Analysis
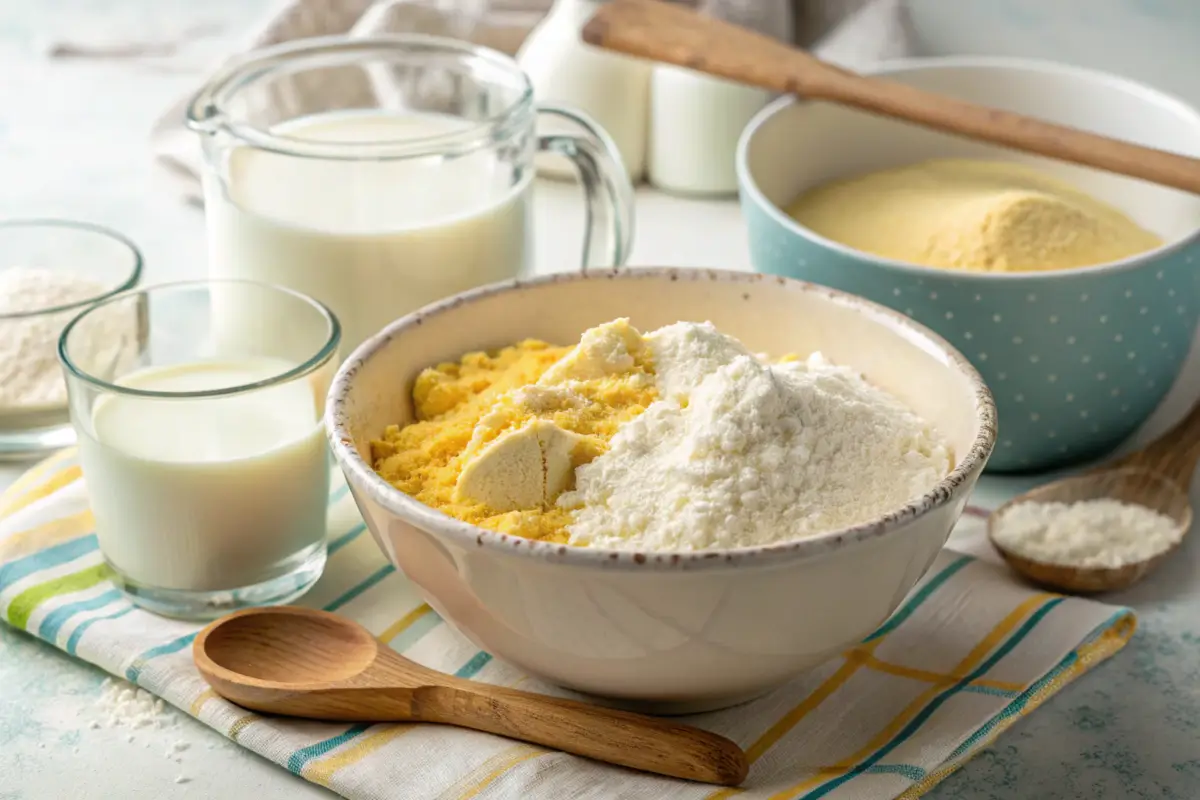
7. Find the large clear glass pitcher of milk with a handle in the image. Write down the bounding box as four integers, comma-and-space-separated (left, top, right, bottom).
187, 34, 632, 354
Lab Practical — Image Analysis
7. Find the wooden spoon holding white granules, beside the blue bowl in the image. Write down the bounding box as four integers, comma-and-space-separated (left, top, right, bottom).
988, 403, 1200, 594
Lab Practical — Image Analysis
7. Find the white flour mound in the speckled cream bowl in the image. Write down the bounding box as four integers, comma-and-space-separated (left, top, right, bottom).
559, 323, 952, 551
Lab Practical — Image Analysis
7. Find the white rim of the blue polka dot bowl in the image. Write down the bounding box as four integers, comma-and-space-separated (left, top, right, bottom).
734, 55, 1200, 283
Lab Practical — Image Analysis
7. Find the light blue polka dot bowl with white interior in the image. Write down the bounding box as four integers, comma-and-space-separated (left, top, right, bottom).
737, 59, 1200, 473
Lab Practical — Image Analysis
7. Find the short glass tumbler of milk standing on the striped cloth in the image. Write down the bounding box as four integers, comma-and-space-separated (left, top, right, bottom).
59, 281, 341, 619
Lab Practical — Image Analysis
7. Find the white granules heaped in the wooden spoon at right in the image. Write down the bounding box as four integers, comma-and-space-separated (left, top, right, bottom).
991, 499, 1183, 569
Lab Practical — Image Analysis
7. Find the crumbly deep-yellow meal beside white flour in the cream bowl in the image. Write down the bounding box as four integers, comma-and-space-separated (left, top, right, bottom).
371, 320, 658, 543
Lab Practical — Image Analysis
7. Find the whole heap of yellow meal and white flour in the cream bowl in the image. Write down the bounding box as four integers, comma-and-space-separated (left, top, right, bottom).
371, 319, 954, 551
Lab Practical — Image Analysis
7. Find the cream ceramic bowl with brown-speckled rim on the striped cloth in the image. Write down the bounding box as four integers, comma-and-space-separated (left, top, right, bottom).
326, 270, 995, 711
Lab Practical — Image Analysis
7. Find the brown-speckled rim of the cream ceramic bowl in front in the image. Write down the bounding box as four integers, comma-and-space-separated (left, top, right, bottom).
325, 267, 996, 570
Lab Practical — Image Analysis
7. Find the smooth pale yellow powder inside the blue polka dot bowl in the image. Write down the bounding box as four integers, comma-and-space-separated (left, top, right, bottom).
786, 158, 1163, 272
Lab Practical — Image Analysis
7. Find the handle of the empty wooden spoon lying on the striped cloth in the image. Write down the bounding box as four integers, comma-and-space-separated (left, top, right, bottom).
413, 686, 749, 786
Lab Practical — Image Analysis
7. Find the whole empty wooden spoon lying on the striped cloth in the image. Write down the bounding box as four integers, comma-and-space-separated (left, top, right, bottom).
192, 606, 749, 786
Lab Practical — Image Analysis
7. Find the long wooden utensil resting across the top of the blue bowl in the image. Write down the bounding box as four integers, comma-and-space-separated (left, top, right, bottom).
583, 0, 1200, 194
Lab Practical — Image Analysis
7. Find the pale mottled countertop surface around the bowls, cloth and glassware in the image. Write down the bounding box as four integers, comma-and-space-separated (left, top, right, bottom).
0, 0, 1200, 800
